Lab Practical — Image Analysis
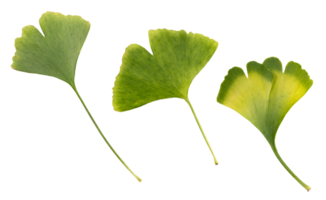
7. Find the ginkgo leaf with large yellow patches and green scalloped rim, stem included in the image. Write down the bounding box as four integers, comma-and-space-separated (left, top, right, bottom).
216, 55, 314, 193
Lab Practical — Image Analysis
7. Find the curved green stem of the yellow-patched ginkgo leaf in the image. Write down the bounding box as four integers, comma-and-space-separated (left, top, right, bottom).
271, 145, 312, 194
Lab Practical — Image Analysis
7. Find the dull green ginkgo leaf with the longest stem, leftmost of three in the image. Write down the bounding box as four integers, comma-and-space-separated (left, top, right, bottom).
10, 10, 143, 183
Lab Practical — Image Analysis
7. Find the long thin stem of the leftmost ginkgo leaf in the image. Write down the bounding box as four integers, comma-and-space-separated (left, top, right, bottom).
71, 84, 143, 184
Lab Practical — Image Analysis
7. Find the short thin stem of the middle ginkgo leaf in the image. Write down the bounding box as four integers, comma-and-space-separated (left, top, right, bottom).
184, 97, 219, 167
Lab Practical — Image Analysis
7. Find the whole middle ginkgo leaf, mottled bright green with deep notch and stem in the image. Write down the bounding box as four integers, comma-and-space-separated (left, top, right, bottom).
112, 27, 219, 166
